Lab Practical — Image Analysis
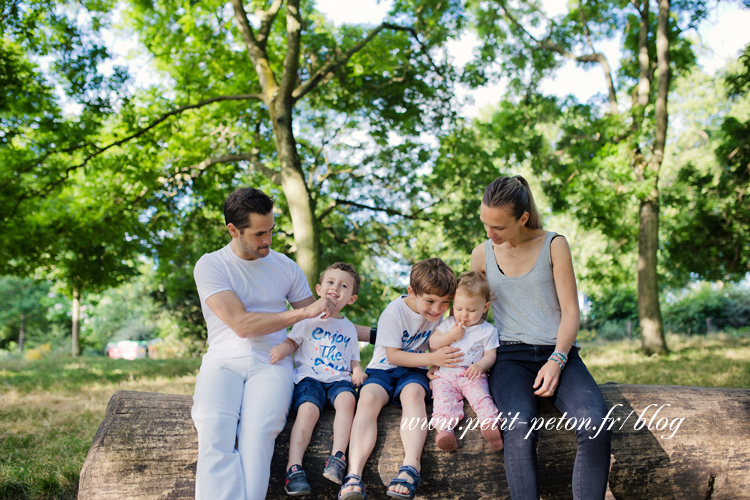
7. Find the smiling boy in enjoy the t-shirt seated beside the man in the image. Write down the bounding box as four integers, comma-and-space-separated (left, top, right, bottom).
271, 262, 367, 496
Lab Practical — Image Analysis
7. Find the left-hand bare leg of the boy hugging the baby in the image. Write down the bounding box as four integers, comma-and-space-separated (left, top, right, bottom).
340, 384, 389, 495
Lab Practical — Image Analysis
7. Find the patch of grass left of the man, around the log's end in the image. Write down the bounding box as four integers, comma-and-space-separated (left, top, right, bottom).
0, 357, 200, 500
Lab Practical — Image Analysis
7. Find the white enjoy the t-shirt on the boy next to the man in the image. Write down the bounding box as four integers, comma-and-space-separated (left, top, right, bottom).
288, 318, 359, 384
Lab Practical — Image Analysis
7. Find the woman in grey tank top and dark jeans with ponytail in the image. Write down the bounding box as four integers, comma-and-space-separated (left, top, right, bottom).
471, 175, 611, 500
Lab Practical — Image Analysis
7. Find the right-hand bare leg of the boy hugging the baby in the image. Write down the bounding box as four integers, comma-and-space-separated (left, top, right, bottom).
389, 384, 427, 495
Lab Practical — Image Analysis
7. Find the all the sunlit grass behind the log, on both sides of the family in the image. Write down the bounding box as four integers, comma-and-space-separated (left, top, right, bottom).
0, 334, 750, 500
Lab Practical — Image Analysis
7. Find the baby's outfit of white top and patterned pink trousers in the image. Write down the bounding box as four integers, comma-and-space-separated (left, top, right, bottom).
432, 316, 500, 431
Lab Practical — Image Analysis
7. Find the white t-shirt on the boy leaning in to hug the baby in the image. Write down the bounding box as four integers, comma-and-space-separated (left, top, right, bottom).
367, 295, 441, 370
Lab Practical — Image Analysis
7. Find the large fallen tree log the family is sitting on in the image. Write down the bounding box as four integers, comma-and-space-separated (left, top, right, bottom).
78, 384, 750, 500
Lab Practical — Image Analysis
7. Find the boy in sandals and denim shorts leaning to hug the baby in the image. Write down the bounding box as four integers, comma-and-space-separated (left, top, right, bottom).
338, 259, 461, 500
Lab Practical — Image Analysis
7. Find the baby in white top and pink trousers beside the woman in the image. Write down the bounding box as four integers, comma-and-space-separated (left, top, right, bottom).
430, 271, 503, 451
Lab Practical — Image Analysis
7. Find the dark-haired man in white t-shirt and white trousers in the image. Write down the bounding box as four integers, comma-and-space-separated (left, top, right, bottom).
192, 188, 340, 500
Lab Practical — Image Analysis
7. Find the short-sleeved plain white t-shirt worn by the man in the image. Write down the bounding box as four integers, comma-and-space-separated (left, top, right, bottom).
193, 245, 312, 367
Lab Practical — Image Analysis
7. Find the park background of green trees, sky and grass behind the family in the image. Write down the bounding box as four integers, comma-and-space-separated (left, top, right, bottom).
0, 0, 750, 499
